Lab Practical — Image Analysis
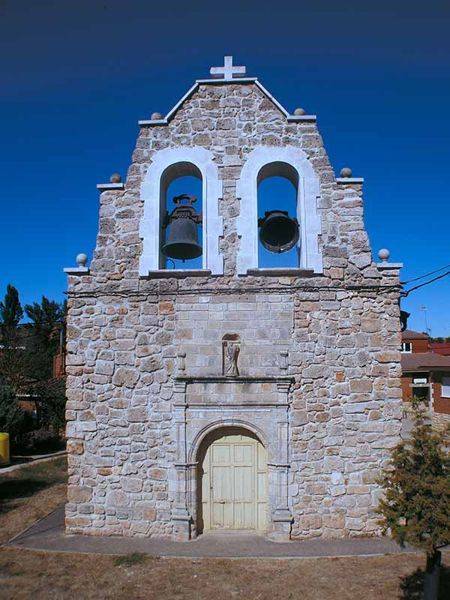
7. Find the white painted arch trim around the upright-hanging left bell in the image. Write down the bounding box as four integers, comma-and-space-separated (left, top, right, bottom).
139, 146, 223, 277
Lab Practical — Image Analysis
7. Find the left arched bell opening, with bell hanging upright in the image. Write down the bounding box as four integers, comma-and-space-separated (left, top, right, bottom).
160, 162, 204, 270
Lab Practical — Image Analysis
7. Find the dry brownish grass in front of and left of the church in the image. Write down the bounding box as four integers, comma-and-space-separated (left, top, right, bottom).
0, 458, 450, 600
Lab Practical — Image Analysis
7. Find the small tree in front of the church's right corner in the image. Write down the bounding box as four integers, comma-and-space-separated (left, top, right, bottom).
378, 408, 450, 600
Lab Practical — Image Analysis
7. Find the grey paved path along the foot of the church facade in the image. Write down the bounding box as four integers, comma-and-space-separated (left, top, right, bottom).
8, 507, 412, 558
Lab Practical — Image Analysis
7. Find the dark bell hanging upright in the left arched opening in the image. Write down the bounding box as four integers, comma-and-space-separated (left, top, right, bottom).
161, 194, 203, 260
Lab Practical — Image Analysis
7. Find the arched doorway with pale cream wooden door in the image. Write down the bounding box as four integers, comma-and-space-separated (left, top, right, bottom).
197, 427, 268, 533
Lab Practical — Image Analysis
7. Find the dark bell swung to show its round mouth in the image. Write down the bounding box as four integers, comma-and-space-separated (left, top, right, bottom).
258, 210, 299, 253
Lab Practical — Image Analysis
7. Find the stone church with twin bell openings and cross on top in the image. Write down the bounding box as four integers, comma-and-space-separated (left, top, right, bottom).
66, 57, 401, 540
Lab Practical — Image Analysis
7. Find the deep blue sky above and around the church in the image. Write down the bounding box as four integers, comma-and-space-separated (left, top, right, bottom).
0, 0, 450, 335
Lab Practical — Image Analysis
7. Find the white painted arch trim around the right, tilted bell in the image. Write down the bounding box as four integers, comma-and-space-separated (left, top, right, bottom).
236, 146, 322, 275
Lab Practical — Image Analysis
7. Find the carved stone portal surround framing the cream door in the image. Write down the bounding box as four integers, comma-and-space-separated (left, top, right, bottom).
170, 375, 292, 540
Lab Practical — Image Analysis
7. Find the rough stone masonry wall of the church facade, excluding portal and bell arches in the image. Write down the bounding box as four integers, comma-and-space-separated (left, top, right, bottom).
66, 84, 401, 537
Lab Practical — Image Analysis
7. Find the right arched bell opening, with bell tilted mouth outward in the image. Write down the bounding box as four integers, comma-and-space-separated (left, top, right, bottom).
257, 161, 300, 268
